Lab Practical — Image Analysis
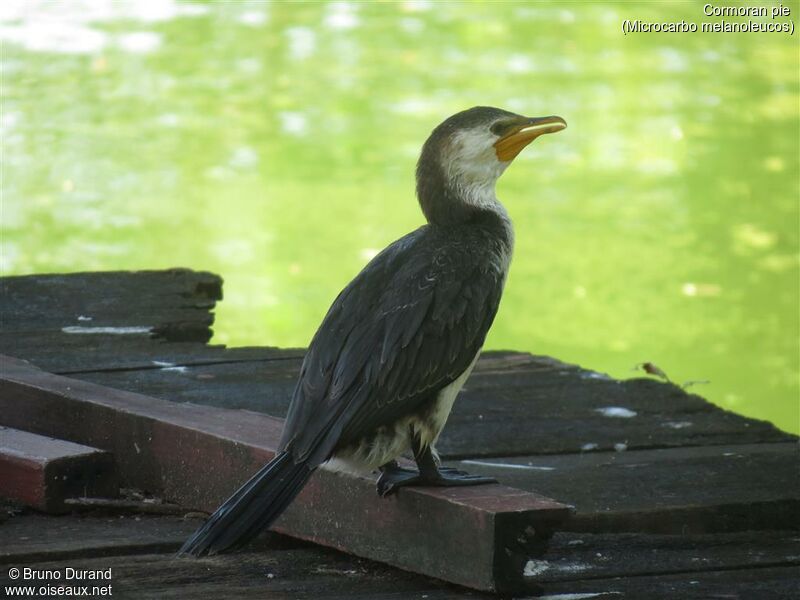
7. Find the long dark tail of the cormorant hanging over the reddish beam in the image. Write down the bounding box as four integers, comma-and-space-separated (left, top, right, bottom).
178, 452, 313, 556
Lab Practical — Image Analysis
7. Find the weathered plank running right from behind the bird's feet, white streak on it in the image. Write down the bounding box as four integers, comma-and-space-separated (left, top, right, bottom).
446, 443, 800, 533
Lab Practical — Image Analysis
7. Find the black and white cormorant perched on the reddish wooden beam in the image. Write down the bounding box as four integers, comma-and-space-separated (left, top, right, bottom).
180, 107, 567, 556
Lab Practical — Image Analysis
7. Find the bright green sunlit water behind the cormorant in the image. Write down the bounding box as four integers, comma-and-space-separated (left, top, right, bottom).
0, 0, 800, 432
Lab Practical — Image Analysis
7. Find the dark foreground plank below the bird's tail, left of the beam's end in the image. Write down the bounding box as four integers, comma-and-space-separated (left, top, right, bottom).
0, 546, 478, 600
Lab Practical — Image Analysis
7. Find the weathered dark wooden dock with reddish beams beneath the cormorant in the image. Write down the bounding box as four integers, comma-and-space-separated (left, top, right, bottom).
0, 270, 800, 600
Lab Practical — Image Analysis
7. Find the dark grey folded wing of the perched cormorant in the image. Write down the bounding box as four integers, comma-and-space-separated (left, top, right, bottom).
281, 230, 503, 464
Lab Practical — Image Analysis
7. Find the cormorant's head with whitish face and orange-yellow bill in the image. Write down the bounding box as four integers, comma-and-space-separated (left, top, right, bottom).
417, 106, 567, 221
